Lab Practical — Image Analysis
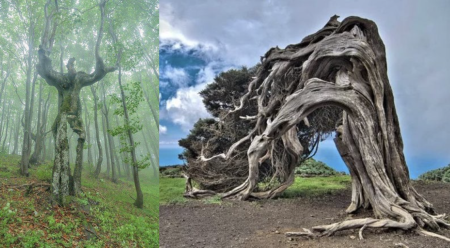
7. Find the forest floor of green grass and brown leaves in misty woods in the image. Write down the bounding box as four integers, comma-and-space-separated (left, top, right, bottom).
0, 154, 159, 247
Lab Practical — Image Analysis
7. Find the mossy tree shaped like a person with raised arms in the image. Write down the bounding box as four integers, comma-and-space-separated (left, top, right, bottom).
36, 0, 116, 204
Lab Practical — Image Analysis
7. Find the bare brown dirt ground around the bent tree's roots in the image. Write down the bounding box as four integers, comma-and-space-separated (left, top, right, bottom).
160, 182, 450, 248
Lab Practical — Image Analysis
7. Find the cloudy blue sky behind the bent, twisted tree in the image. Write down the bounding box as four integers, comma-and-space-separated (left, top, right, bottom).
160, 0, 450, 178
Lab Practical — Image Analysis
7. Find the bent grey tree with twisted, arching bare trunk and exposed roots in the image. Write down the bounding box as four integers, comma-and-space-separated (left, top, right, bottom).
196, 16, 450, 241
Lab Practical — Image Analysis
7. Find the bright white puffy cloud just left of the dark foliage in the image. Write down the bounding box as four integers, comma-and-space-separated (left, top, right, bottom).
164, 83, 211, 132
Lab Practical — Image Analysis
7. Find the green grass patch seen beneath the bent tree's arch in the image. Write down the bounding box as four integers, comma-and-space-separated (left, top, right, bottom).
281, 175, 351, 198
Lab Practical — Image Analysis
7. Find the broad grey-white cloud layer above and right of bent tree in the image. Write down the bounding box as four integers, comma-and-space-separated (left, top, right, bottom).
160, 0, 450, 158
